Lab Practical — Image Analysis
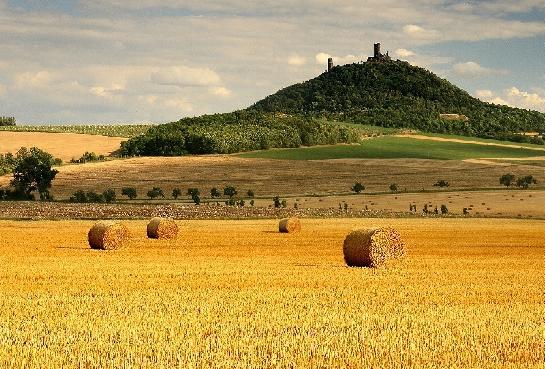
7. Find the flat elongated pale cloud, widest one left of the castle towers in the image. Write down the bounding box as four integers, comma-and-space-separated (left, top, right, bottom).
151, 66, 221, 87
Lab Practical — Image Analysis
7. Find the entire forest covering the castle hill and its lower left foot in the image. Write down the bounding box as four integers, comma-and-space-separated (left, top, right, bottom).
121, 61, 545, 156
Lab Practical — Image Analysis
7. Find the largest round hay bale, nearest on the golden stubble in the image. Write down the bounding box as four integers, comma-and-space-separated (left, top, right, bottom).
343, 228, 392, 267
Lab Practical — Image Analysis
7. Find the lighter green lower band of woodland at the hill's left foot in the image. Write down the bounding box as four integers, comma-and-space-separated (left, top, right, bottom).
121, 110, 359, 156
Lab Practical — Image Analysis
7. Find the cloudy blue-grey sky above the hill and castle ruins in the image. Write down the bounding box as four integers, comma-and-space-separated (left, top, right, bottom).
0, 0, 545, 124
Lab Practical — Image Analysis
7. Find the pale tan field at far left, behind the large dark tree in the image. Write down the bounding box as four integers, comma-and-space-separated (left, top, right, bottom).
0, 131, 126, 161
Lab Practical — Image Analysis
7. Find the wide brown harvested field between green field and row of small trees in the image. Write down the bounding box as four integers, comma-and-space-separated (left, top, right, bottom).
0, 155, 545, 199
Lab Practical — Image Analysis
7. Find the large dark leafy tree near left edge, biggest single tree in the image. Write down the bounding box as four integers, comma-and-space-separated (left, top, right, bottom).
11, 147, 58, 200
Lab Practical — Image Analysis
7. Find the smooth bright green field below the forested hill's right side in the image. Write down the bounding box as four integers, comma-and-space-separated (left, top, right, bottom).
240, 137, 545, 160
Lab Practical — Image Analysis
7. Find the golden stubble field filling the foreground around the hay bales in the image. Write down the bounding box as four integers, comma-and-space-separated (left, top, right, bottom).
0, 219, 545, 368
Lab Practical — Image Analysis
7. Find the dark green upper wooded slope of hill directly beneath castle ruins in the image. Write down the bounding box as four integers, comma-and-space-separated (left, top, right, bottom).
250, 61, 545, 140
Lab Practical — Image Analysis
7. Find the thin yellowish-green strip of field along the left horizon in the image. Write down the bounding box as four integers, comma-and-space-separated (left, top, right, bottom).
0, 124, 152, 138
